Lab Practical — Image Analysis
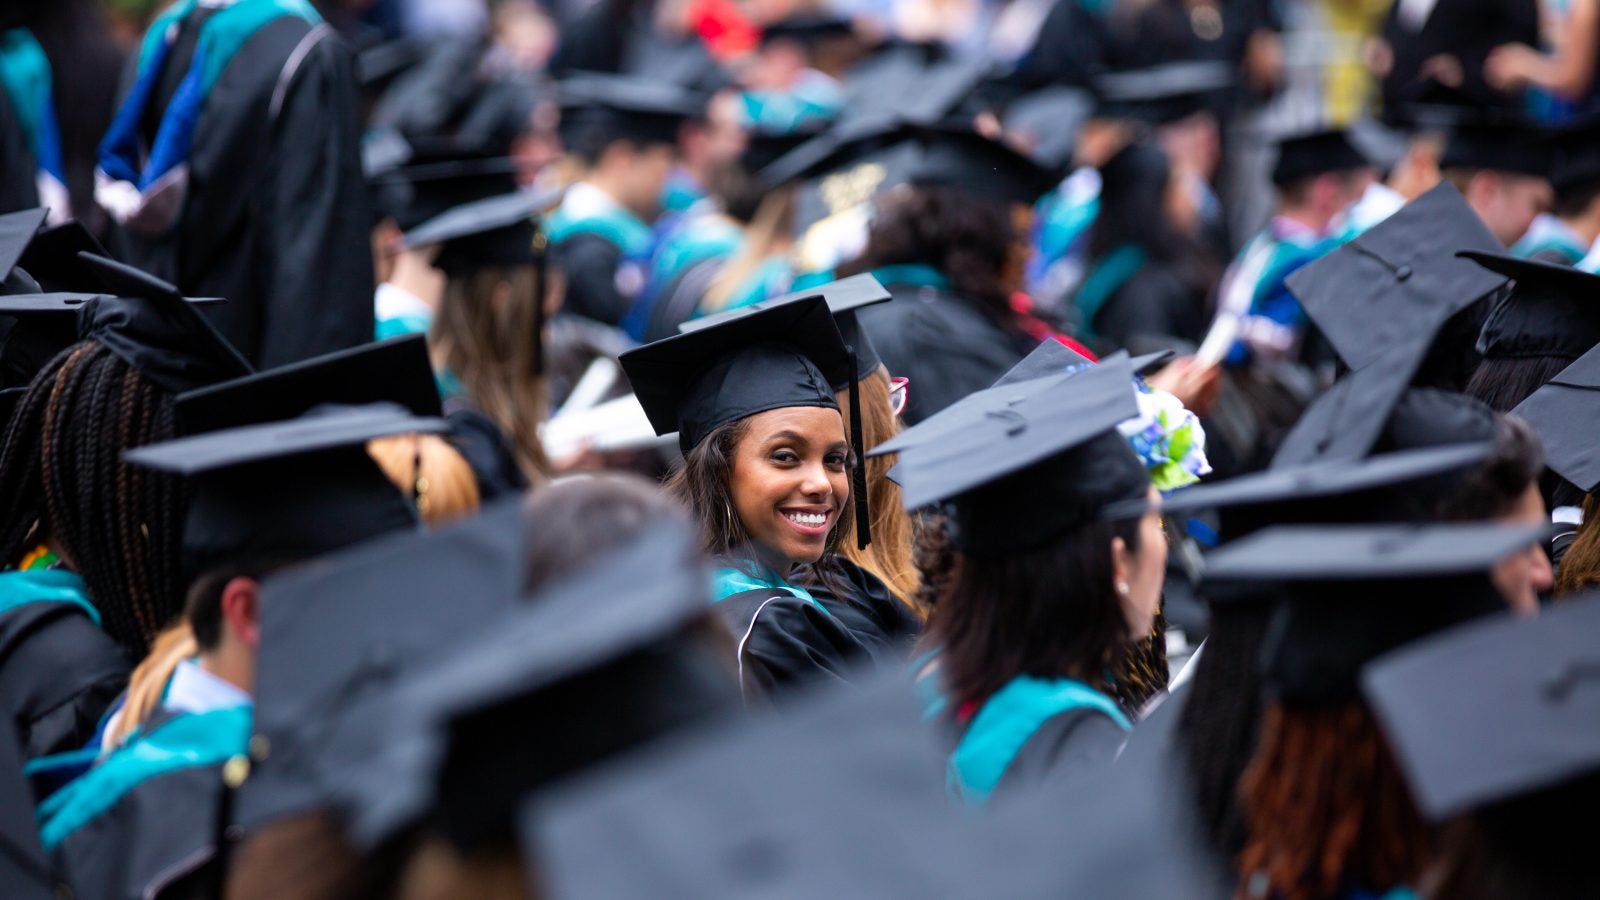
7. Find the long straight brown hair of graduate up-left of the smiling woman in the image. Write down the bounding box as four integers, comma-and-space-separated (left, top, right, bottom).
429, 266, 550, 484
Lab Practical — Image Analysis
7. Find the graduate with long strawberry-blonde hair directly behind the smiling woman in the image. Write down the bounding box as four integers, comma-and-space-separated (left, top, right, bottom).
680, 274, 926, 655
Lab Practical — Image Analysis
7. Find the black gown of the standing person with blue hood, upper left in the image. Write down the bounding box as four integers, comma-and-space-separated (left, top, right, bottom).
110, 16, 373, 368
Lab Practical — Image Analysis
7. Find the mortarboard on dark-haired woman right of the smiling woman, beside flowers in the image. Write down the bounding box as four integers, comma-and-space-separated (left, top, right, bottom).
894, 352, 1150, 556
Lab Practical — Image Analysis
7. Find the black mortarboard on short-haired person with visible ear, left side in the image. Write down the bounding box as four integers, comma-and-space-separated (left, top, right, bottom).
123, 398, 446, 577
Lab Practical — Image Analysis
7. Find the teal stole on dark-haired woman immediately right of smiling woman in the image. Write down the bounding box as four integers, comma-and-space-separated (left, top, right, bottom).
925, 676, 1133, 809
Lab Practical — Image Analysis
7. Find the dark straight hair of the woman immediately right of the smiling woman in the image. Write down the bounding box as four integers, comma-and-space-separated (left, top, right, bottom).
926, 519, 1139, 714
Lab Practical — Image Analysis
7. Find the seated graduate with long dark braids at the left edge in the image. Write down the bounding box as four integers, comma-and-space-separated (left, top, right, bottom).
0, 241, 250, 759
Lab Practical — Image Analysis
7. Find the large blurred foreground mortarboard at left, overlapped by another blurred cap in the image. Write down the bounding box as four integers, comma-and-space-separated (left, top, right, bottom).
238, 500, 528, 828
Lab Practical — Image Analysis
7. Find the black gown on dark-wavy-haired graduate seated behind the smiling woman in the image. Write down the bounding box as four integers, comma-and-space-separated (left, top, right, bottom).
856, 285, 1038, 424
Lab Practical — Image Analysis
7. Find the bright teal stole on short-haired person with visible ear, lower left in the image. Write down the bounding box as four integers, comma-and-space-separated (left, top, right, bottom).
38, 706, 253, 850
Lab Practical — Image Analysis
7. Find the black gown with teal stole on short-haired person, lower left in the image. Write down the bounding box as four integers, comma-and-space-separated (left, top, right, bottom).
40, 706, 251, 900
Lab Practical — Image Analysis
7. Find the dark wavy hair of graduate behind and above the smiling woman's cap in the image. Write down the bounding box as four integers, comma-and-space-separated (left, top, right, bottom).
837, 184, 1018, 318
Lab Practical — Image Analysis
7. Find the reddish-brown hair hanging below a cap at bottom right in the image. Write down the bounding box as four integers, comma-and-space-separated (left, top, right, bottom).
1238, 703, 1434, 900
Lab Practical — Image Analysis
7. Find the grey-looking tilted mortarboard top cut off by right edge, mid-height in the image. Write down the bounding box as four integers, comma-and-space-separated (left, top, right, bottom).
1512, 339, 1600, 493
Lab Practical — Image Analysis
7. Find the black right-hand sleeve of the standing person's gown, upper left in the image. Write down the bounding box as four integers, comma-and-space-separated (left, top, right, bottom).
256, 29, 374, 368
